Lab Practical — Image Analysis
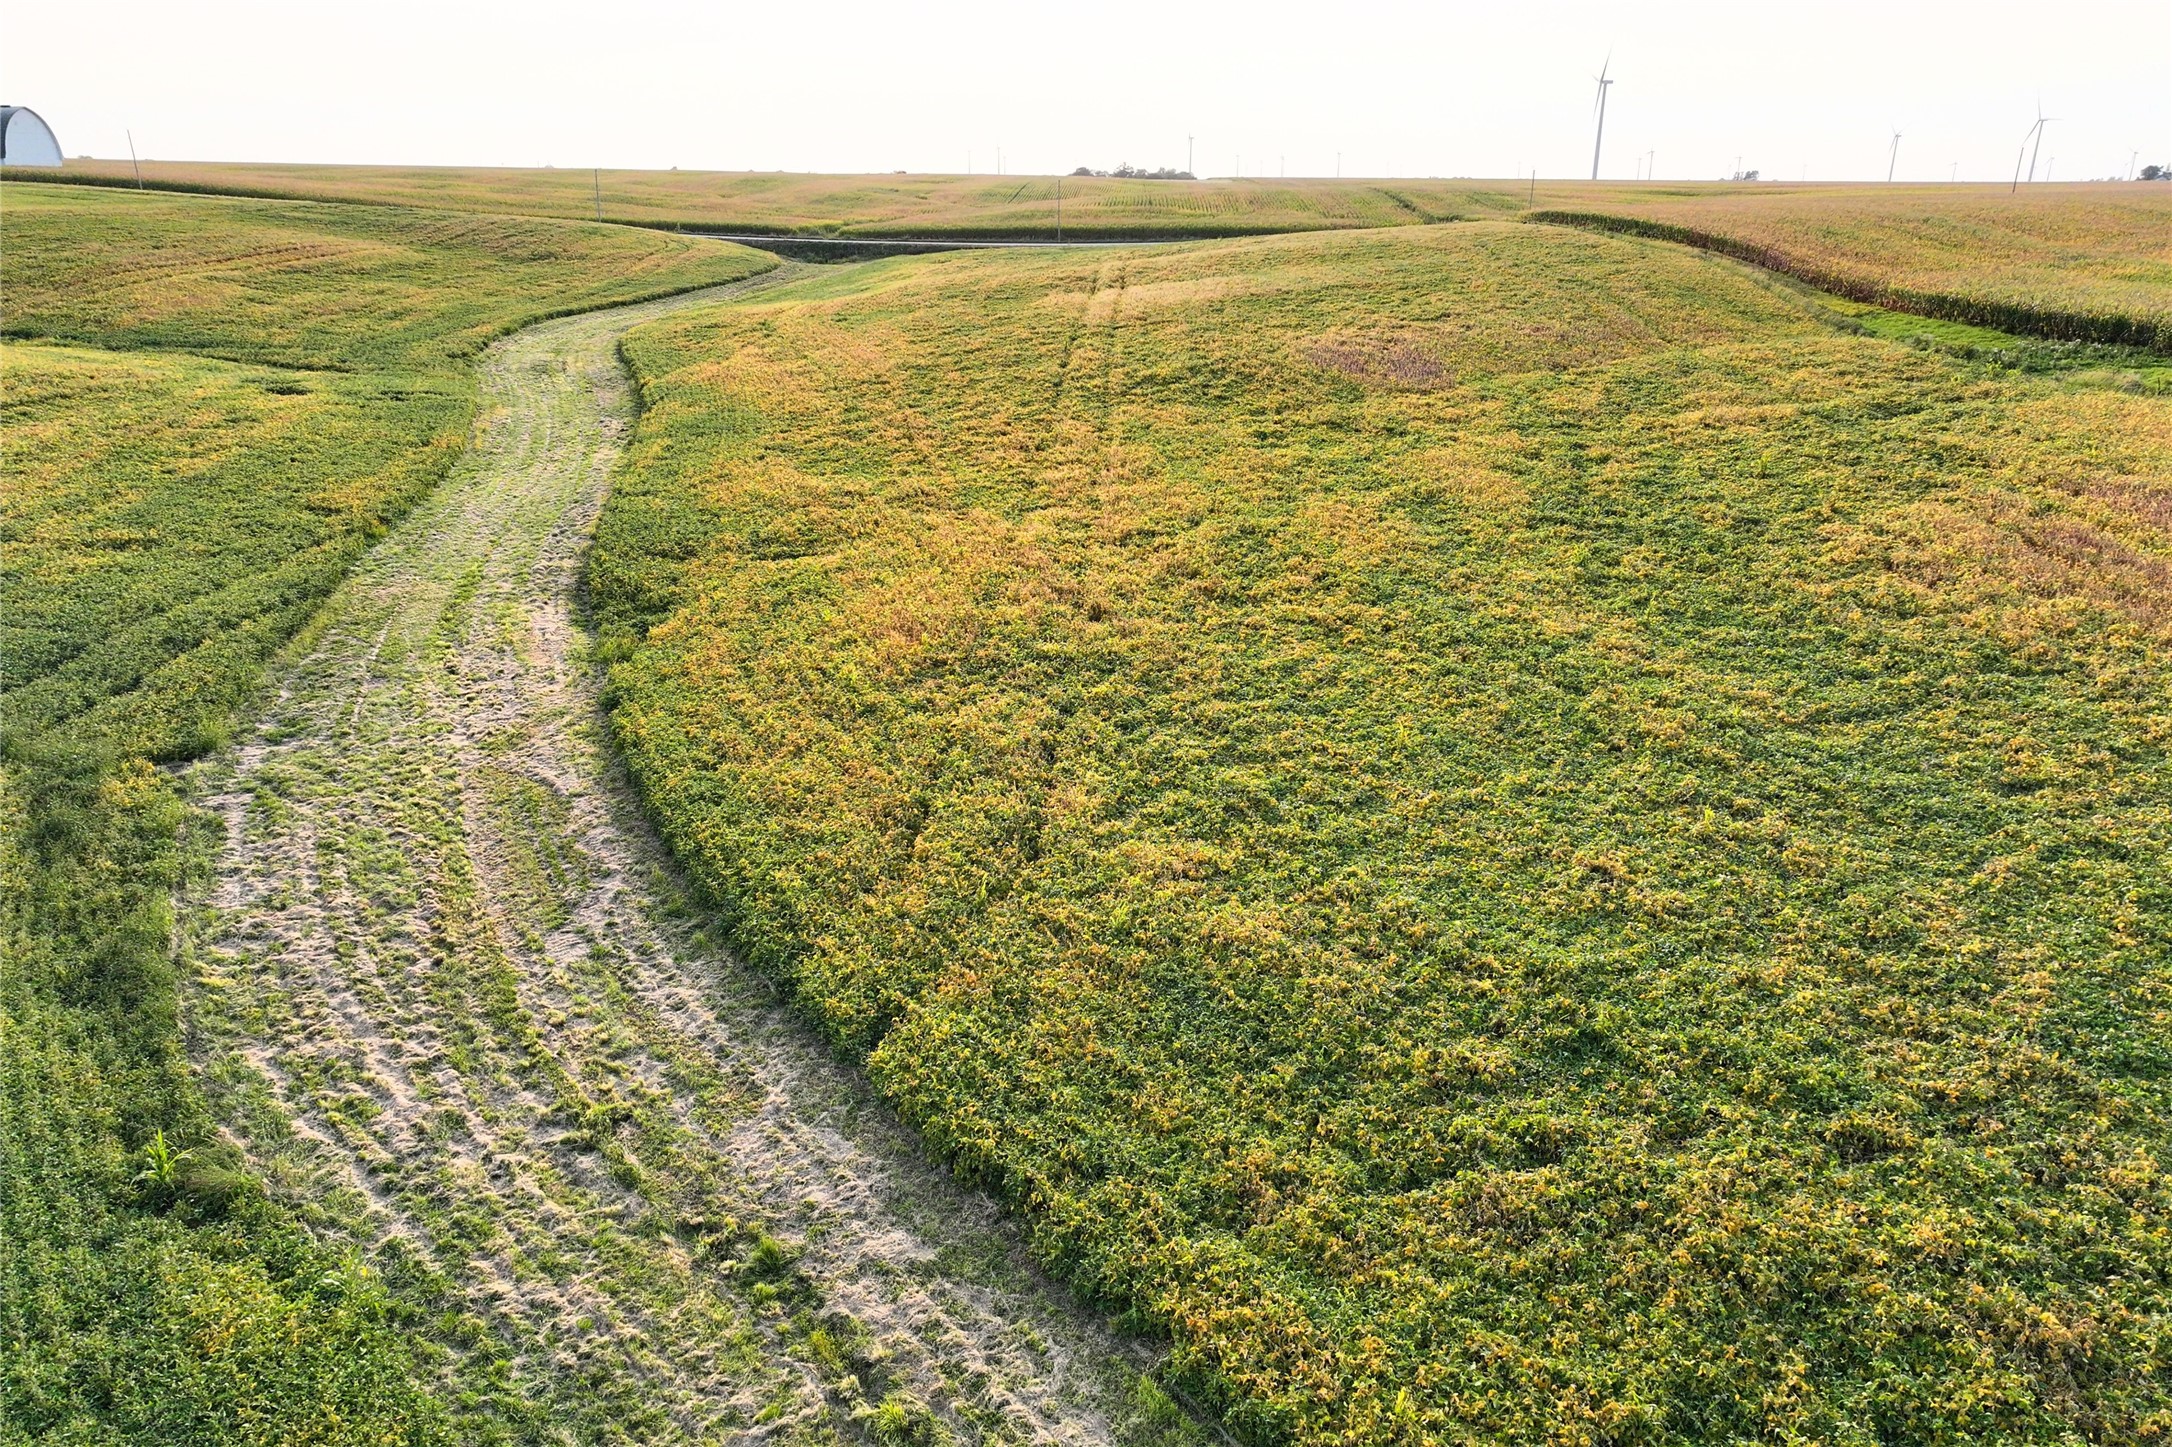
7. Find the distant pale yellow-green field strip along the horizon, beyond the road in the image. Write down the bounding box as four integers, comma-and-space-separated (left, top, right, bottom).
11, 161, 1523, 239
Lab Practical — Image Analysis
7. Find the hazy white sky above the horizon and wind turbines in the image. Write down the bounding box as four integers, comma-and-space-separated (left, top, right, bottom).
0, 0, 2172, 180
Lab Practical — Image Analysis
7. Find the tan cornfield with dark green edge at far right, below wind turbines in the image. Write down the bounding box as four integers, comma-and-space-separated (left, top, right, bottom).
1536, 183, 2172, 352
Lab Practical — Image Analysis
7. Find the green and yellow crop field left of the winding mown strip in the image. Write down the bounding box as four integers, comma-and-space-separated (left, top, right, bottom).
0, 185, 769, 1443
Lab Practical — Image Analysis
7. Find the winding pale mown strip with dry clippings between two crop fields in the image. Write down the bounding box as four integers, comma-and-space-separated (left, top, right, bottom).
185, 267, 1199, 1443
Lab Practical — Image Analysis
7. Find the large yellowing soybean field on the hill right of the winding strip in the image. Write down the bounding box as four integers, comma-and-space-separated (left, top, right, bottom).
591, 226, 2172, 1443
